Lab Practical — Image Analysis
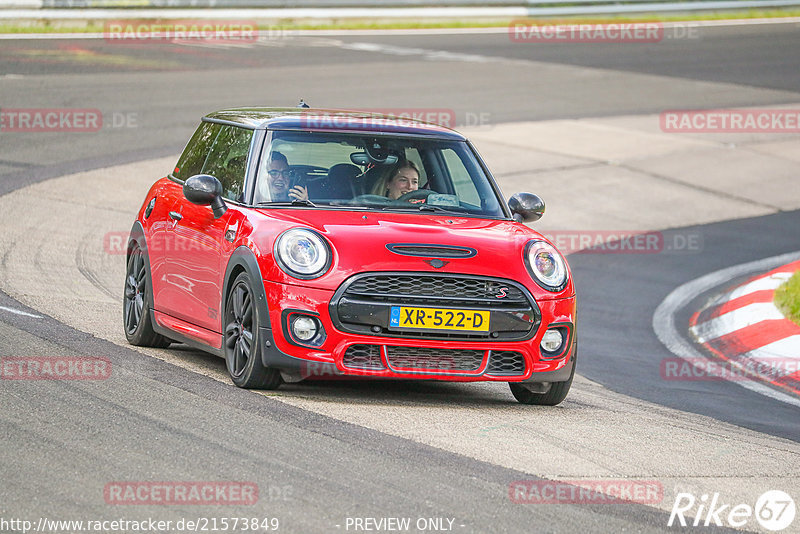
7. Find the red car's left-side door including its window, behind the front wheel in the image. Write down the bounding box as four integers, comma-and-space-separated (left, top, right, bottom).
167, 125, 253, 332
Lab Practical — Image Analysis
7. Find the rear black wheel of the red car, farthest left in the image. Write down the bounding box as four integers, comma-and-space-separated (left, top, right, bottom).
122, 241, 172, 349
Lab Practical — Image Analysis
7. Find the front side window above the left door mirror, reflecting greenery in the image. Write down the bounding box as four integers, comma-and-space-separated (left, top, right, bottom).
202, 126, 253, 202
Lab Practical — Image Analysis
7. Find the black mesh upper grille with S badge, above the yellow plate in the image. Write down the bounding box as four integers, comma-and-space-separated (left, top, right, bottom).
345, 275, 528, 306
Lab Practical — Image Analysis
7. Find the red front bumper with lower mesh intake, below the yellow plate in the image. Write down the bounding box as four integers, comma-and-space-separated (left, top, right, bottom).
258, 281, 577, 382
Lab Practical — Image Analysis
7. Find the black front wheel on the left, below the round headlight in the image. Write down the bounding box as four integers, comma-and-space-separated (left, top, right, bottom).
222, 272, 283, 389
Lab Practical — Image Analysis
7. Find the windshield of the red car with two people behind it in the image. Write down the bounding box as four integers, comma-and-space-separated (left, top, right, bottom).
254, 131, 504, 217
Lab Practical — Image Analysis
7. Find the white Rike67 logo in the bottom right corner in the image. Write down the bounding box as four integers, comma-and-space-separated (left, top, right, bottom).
667, 490, 796, 532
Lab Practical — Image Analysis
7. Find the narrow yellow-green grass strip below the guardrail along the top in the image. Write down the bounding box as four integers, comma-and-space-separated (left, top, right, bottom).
0, 9, 800, 34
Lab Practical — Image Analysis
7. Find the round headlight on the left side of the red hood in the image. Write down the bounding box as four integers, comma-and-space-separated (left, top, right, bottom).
275, 228, 331, 280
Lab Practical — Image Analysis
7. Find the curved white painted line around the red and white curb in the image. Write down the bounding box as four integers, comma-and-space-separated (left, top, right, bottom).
653, 252, 800, 407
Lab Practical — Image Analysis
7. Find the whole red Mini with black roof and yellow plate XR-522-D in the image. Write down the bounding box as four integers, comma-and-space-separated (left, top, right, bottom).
123, 108, 577, 405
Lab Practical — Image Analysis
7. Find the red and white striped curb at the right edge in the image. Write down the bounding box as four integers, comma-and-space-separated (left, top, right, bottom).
689, 261, 800, 394
